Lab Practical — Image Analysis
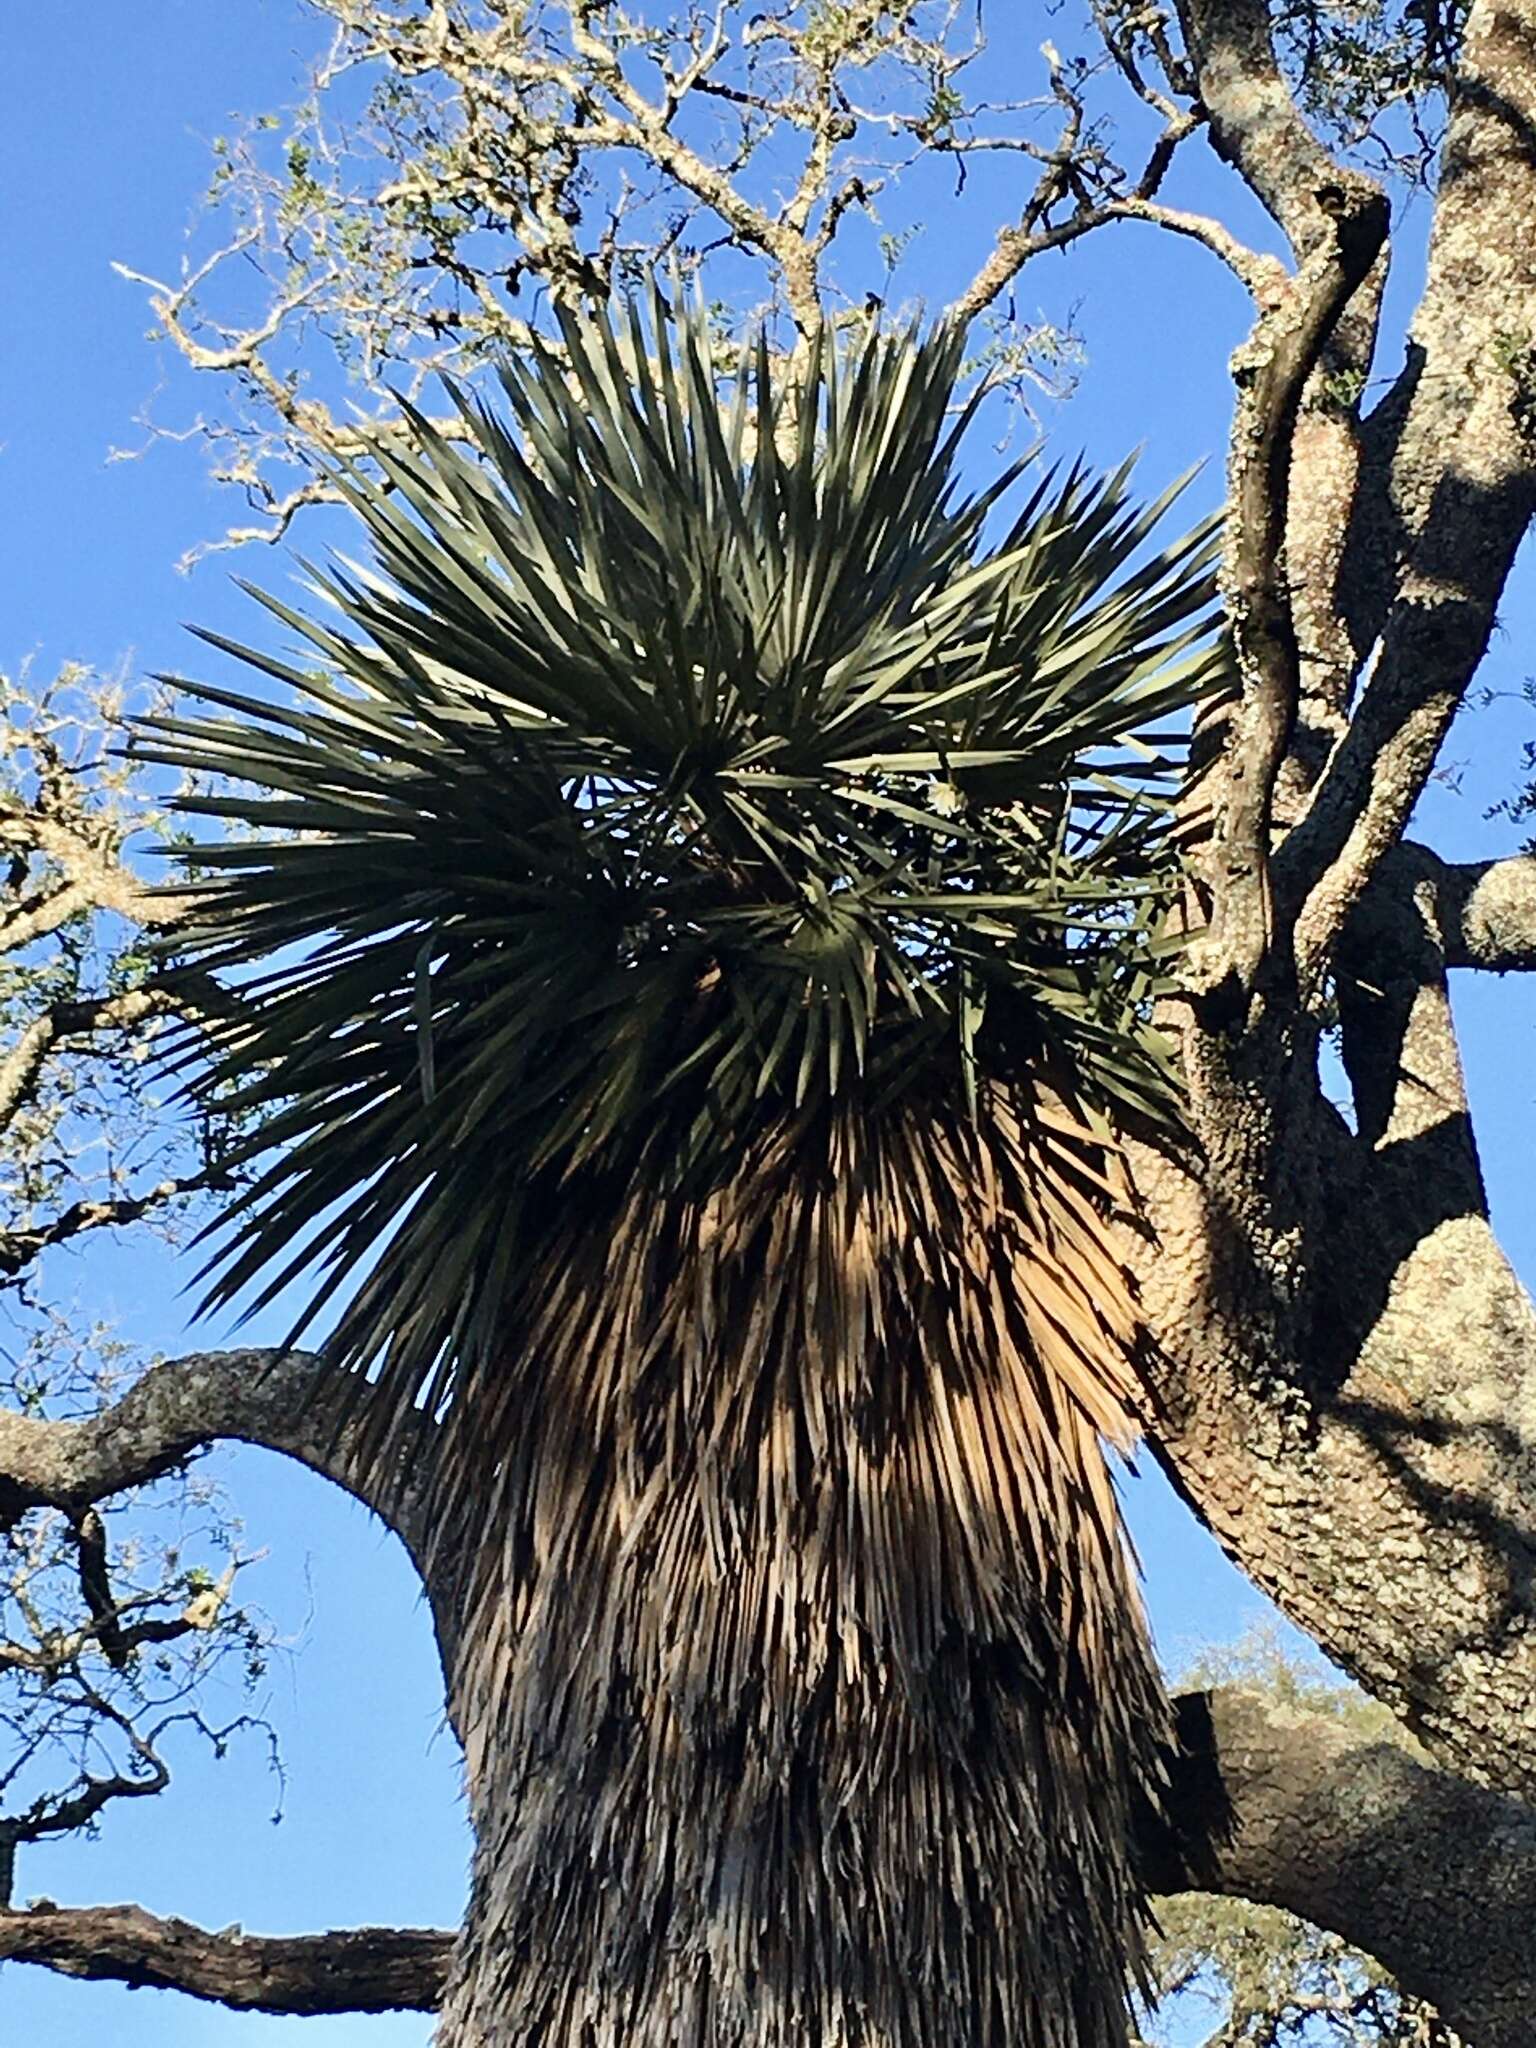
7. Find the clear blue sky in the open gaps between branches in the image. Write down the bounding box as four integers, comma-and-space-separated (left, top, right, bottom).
0, 0, 1536, 2048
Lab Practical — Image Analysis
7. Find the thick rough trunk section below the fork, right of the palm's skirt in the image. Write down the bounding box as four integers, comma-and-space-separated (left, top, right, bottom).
1126, 946, 1536, 1798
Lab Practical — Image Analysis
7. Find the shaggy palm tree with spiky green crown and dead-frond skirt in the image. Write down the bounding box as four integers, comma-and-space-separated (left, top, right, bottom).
143, 297, 1221, 2048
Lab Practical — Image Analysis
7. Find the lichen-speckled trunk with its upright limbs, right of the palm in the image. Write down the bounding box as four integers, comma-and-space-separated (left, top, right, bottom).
1137, 0, 1536, 1796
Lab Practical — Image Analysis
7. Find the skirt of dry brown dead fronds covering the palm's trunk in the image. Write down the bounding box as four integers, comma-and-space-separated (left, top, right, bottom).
421, 1105, 1163, 2048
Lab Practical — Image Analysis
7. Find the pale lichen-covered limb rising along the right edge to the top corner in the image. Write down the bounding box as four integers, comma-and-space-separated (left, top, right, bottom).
1278, 0, 1536, 987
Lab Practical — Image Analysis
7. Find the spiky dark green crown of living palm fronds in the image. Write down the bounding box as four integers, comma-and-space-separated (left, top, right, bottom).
141, 303, 1221, 1458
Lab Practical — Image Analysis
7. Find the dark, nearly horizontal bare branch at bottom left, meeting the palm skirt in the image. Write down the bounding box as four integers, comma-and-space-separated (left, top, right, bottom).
0, 1901, 453, 2015
